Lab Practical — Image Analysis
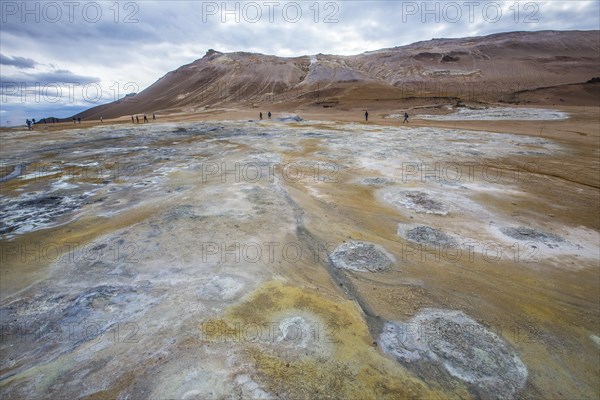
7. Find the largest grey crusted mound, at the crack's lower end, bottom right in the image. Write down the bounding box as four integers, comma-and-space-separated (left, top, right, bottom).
379, 309, 527, 399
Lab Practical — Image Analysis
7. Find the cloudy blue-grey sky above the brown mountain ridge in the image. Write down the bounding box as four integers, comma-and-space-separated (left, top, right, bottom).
0, 0, 600, 126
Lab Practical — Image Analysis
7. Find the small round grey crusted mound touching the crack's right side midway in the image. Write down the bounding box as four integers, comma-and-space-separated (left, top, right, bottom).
329, 240, 396, 272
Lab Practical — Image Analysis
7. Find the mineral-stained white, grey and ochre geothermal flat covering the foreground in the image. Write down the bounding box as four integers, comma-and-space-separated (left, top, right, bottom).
0, 109, 600, 399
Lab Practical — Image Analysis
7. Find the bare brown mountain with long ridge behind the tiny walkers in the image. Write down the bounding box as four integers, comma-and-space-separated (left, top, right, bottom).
75, 31, 600, 119
